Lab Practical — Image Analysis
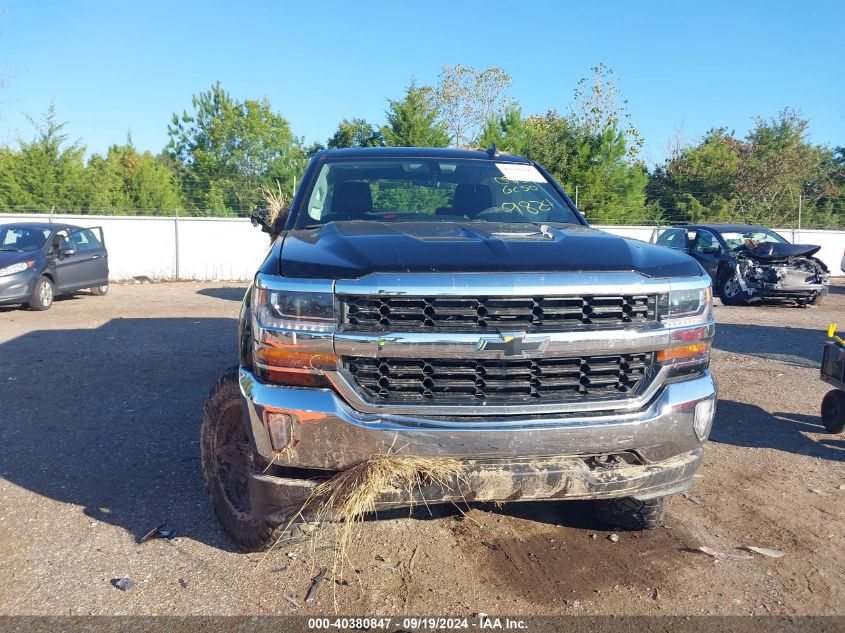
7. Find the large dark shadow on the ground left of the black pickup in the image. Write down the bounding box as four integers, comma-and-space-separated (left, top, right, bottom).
0, 317, 241, 549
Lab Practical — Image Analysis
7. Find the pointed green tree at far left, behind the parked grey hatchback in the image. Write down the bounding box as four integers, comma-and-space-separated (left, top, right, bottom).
0, 104, 87, 211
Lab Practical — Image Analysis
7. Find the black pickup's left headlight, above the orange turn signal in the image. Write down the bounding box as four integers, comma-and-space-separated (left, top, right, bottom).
252, 287, 335, 332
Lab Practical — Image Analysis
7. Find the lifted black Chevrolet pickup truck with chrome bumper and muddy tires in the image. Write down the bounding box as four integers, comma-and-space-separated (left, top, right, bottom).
200, 147, 716, 550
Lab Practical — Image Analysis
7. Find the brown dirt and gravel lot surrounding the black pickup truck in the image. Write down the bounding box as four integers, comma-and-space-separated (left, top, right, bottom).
0, 283, 845, 616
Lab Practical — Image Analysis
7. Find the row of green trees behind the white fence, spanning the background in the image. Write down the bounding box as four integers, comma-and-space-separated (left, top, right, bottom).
0, 65, 845, 228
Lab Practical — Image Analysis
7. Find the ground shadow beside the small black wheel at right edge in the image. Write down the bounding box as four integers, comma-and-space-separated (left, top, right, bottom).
710, 400, 845, 462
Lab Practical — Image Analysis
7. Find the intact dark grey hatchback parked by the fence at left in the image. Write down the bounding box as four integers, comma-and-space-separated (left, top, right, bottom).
0, 222, 109, 310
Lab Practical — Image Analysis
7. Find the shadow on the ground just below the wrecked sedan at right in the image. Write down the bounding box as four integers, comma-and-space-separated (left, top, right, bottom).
713, 323, 827, 368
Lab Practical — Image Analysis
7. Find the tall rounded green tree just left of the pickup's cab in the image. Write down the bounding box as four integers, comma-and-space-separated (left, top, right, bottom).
167, 82, 301, 214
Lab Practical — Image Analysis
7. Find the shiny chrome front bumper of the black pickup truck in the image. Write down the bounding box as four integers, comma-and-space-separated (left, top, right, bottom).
240, 368, 716, 471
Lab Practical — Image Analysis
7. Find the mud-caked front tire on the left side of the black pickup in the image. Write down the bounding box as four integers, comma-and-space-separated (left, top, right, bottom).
200, 366, 307, 552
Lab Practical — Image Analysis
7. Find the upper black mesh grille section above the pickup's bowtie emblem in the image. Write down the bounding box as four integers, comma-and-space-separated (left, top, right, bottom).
340, 295, 657, 331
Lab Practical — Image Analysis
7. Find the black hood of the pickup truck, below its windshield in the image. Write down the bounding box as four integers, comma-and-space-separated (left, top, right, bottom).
279, 221, 703, 279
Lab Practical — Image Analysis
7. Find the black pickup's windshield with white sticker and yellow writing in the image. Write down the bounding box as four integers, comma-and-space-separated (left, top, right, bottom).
296, 158, 581, 227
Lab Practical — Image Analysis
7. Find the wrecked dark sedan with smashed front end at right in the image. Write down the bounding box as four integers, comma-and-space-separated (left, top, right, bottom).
652, 224, 830, 306
